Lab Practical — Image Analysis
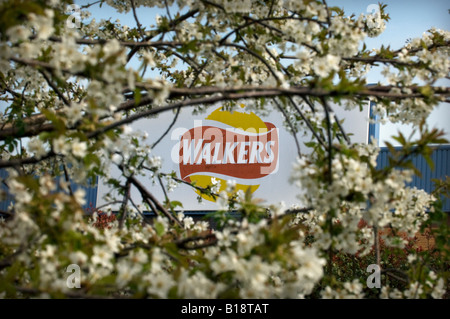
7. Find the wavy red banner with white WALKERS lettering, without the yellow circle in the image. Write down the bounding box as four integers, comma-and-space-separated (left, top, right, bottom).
179, 122, 279, 182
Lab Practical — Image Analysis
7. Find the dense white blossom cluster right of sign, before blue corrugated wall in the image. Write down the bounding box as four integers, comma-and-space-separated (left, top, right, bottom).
292, 144, 435, 254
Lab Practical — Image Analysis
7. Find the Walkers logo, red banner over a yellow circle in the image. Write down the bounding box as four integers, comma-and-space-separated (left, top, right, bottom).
172, 105, 279, 201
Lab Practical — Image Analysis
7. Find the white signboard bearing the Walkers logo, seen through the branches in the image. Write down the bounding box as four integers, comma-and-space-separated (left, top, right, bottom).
97, 101, 369, 211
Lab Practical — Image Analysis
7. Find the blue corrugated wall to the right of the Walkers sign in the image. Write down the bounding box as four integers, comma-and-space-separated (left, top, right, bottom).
377, 145, 450, 212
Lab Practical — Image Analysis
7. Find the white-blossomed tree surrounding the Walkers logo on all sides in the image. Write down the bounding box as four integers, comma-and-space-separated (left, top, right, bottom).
0, 0, 450, 298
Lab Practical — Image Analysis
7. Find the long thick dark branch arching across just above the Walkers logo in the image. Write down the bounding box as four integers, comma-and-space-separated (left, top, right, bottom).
0, 83, 450, 148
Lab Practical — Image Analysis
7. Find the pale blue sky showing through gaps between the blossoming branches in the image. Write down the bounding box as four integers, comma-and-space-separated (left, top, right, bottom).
81, 0, 450, 146
